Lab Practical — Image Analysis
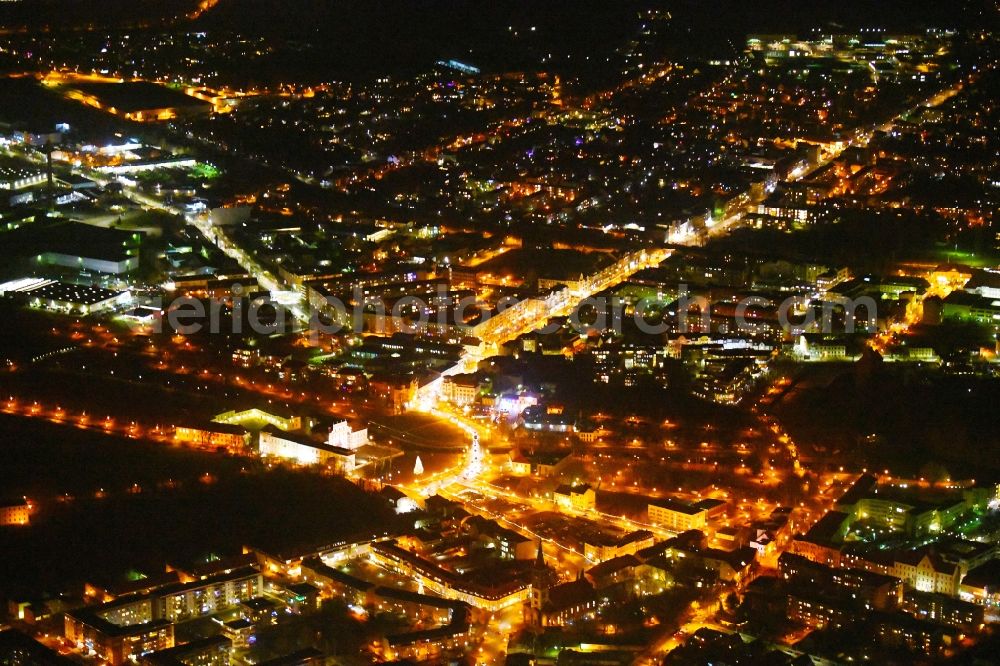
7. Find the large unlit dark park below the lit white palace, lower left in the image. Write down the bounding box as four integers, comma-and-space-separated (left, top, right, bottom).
0, 416, 393, 596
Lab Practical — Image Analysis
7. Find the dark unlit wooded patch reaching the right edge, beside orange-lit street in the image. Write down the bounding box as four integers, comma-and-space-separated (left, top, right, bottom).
773, 364, 1000, 482
